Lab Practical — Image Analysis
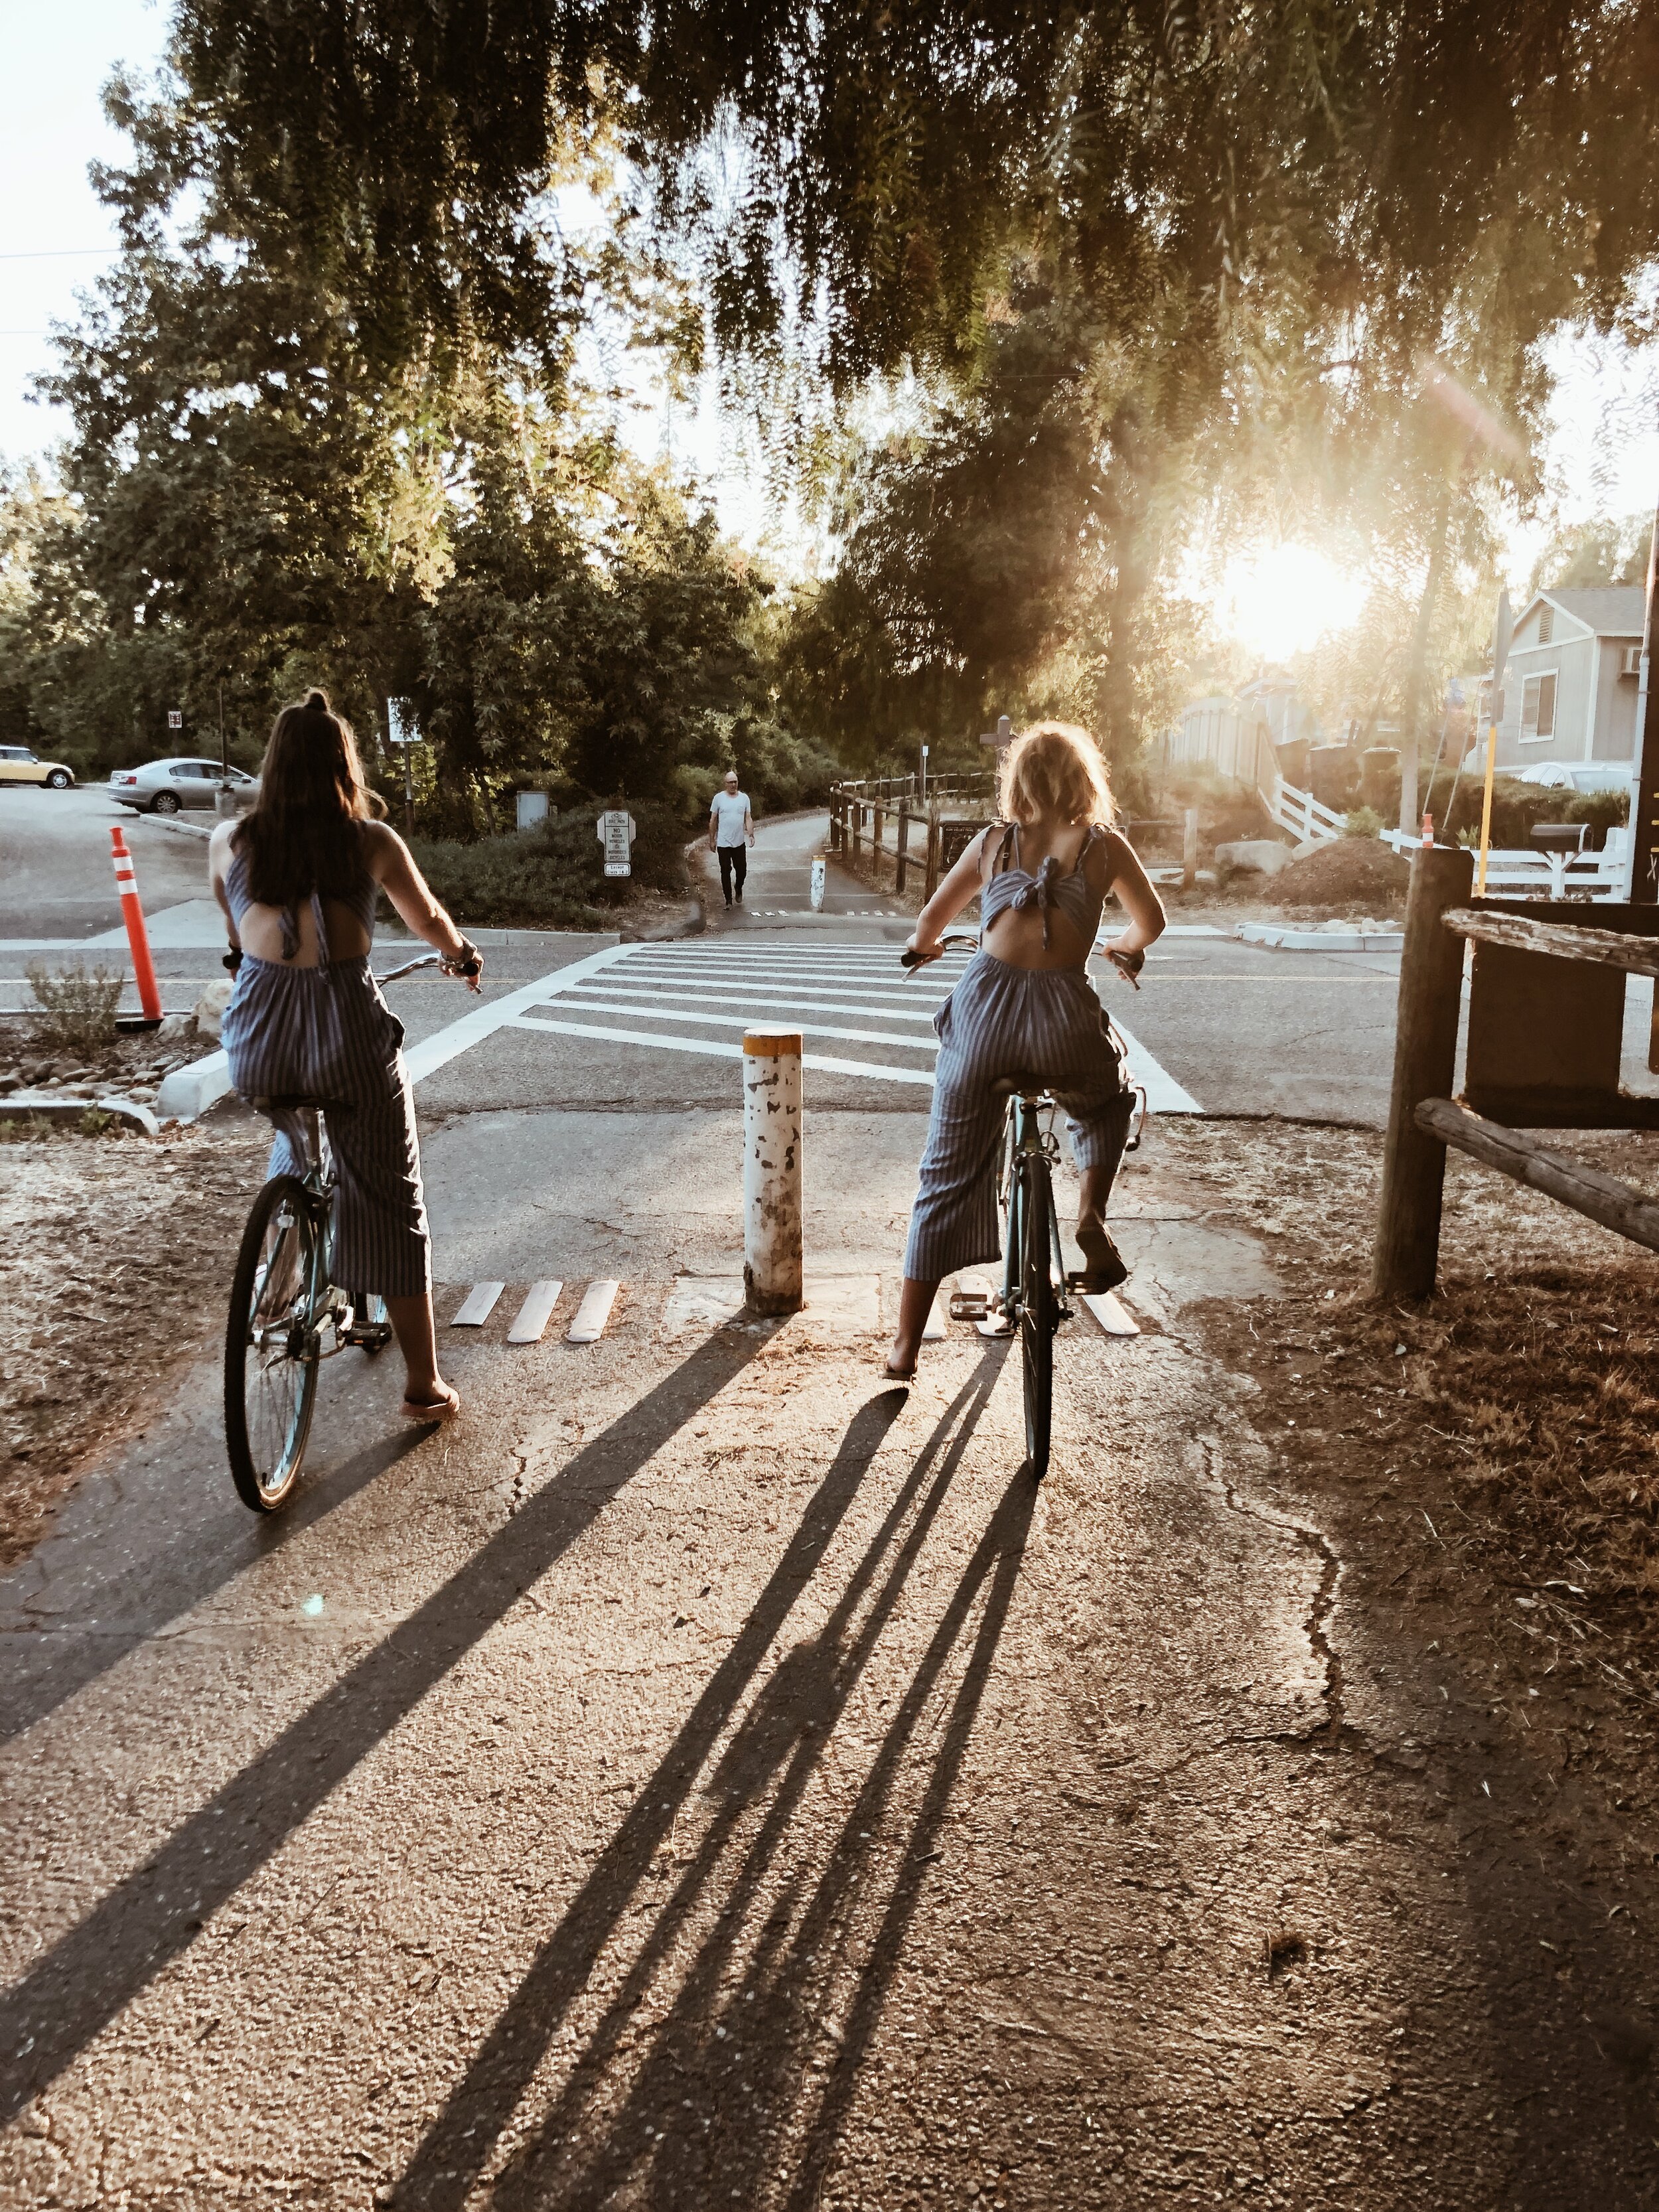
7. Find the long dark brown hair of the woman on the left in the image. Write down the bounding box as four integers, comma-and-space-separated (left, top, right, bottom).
232, 690, 385, 907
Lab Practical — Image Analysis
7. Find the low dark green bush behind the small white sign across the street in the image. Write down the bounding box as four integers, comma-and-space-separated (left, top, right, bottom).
409, 801, 688, 929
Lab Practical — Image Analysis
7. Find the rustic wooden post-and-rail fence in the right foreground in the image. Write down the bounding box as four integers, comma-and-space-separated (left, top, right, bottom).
1372, 845, 1659, 1298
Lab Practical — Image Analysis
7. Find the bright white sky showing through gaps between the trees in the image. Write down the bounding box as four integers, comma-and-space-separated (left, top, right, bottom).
0, 0, 1659, 659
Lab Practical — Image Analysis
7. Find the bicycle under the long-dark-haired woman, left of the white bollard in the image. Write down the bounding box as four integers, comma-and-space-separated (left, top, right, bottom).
226, 954, 455, 1513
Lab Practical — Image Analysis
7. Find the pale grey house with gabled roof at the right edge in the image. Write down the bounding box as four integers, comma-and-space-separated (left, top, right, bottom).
1471, 584, 1646, 774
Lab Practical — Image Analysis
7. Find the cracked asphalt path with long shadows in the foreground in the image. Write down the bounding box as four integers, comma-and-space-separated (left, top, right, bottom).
0, 1112, 1659, 2212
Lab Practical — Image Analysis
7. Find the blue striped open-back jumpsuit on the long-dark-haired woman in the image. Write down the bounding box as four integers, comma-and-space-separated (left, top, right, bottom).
219, 854, 431, 1298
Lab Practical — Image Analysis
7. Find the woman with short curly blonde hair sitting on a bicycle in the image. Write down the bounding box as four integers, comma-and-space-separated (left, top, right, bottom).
887, 721, 1163, 1382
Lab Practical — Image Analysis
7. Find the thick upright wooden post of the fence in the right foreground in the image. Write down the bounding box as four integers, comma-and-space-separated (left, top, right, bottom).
1372, 845, 1475, 1298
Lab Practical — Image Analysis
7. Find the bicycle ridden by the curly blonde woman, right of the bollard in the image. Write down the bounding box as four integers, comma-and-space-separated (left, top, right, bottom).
901, 931, 1146, 1482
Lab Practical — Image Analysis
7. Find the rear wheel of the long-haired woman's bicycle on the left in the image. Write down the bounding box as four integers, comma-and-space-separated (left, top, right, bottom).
226, 1175, 317, 1513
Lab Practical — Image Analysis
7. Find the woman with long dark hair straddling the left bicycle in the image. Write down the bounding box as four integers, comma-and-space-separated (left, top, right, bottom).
208, 690, 482, 1420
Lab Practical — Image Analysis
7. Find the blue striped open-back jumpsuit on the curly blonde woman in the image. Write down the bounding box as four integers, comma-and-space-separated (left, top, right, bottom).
904, 825, 1135, 1283
